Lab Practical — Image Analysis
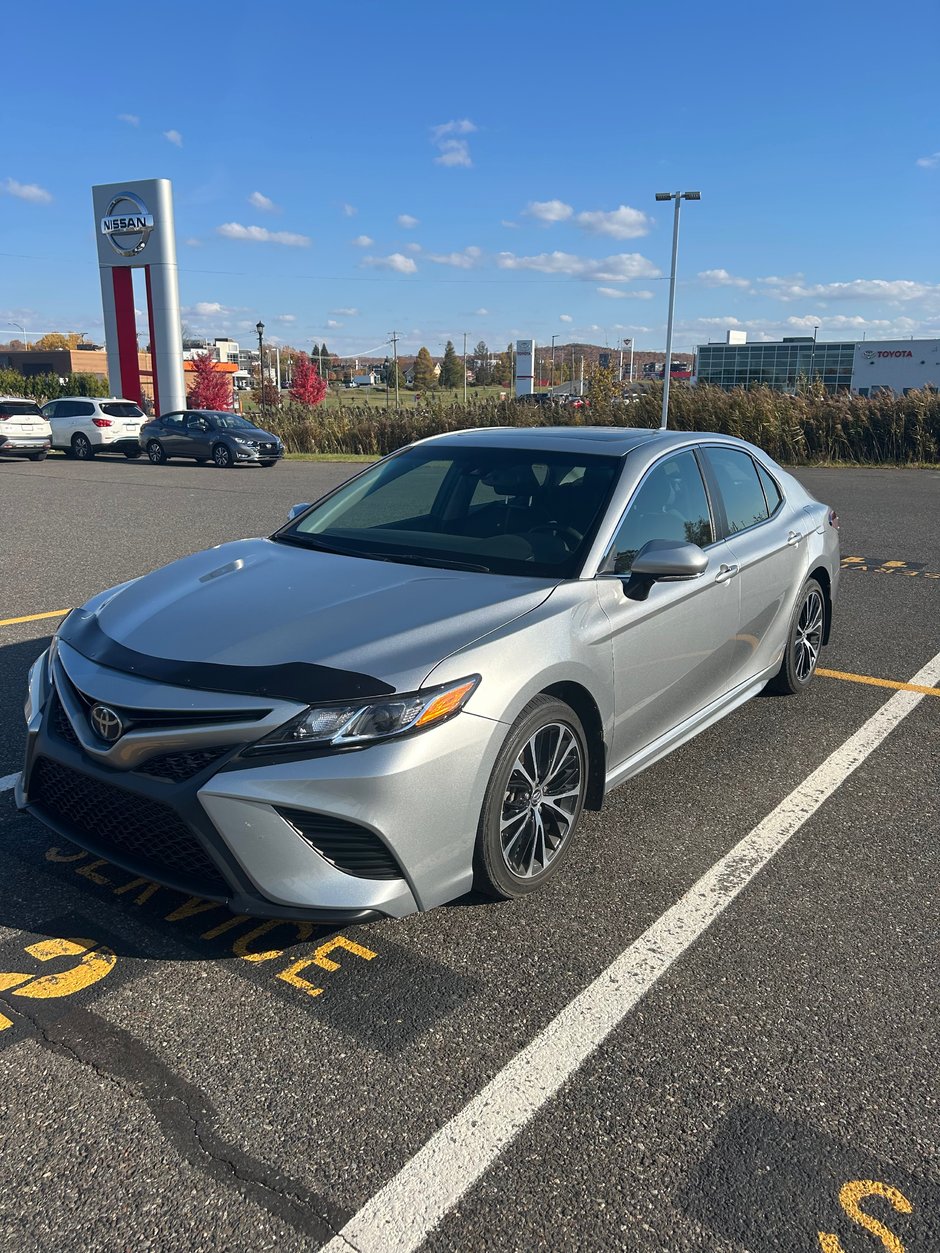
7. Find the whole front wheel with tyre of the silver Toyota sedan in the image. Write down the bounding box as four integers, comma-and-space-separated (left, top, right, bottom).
476, 695, 588, 900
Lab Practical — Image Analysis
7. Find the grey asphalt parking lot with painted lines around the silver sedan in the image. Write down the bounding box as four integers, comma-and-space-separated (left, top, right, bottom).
0, 457, 940, 1253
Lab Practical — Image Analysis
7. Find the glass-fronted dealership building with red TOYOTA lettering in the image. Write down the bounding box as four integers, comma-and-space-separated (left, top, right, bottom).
694, 331, 940, 396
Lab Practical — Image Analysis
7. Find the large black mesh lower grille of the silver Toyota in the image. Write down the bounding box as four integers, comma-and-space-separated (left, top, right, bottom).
29, 757, 231, 896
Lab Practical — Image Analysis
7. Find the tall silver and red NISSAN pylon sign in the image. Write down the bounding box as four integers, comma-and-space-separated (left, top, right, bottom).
91, 178, 185, 413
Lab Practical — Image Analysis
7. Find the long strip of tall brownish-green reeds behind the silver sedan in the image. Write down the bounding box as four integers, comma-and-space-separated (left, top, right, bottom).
263, 383, 940, 465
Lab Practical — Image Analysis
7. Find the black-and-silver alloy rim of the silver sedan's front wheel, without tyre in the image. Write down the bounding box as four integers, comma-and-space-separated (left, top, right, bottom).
500, 722, 584, 878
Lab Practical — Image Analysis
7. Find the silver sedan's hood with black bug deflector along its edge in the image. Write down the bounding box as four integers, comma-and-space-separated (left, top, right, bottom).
67, 539, 554, 702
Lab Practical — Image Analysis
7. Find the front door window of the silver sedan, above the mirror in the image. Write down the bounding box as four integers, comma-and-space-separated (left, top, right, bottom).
607, 452, 714, 574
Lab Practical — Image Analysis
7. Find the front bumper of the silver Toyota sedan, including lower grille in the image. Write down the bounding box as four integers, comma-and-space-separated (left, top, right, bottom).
16, 645, 505, 923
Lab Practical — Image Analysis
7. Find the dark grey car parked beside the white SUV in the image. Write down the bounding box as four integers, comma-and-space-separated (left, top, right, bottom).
140, 408, 285, 470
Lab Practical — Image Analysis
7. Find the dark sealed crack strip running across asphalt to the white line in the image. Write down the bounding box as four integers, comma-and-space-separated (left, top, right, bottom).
18, 1006, 358, 1253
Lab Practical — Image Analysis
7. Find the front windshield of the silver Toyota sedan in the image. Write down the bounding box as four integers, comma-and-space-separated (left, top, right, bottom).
274, 445, 622, 579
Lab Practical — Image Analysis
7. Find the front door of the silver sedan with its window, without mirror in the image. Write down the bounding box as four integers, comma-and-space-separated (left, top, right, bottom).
598, 451, 741, 769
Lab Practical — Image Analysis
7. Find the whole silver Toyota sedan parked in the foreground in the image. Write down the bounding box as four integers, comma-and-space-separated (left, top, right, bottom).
16, 427, 838, 922
